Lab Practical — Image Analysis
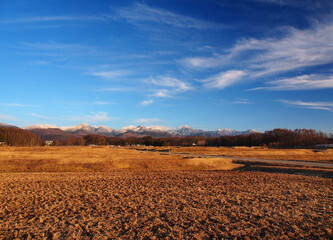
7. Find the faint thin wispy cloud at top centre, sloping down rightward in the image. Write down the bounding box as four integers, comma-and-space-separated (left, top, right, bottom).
116, 2, 222, 29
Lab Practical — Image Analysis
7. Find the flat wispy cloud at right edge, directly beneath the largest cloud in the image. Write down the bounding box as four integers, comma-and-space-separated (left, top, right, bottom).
250, 74, 333, 90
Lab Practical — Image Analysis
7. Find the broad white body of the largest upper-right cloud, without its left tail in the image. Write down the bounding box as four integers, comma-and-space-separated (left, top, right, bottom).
235, 22, 333, 77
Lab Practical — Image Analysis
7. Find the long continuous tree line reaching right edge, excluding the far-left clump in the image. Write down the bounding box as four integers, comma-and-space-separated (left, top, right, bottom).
57, 128, 333, 148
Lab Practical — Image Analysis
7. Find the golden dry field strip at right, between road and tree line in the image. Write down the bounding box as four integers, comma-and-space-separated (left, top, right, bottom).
158, 147, 333, 163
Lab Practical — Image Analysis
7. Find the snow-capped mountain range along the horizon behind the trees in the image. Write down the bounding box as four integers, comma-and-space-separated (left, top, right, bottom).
16, 123, 258, 140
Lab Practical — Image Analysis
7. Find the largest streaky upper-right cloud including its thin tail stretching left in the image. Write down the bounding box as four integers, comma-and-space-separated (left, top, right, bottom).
180, 21, 333, 86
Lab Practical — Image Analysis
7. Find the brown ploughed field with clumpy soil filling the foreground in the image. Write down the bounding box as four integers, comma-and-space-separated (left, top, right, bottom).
0, 171, 333, 239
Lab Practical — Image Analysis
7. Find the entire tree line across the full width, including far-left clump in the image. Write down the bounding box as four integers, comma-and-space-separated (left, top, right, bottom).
0, 128, 333, 148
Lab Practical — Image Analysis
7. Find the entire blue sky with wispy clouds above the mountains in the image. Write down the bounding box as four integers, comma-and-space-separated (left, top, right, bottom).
0, 0, 333, 133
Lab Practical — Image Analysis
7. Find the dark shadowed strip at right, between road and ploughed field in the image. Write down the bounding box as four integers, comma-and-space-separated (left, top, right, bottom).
234, 160, 333, 178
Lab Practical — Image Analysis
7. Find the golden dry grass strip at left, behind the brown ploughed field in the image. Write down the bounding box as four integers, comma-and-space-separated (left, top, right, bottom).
0, 147, 241, 172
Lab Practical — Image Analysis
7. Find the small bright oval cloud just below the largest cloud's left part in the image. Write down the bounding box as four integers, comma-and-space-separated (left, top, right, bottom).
204, 70, 245, 89
